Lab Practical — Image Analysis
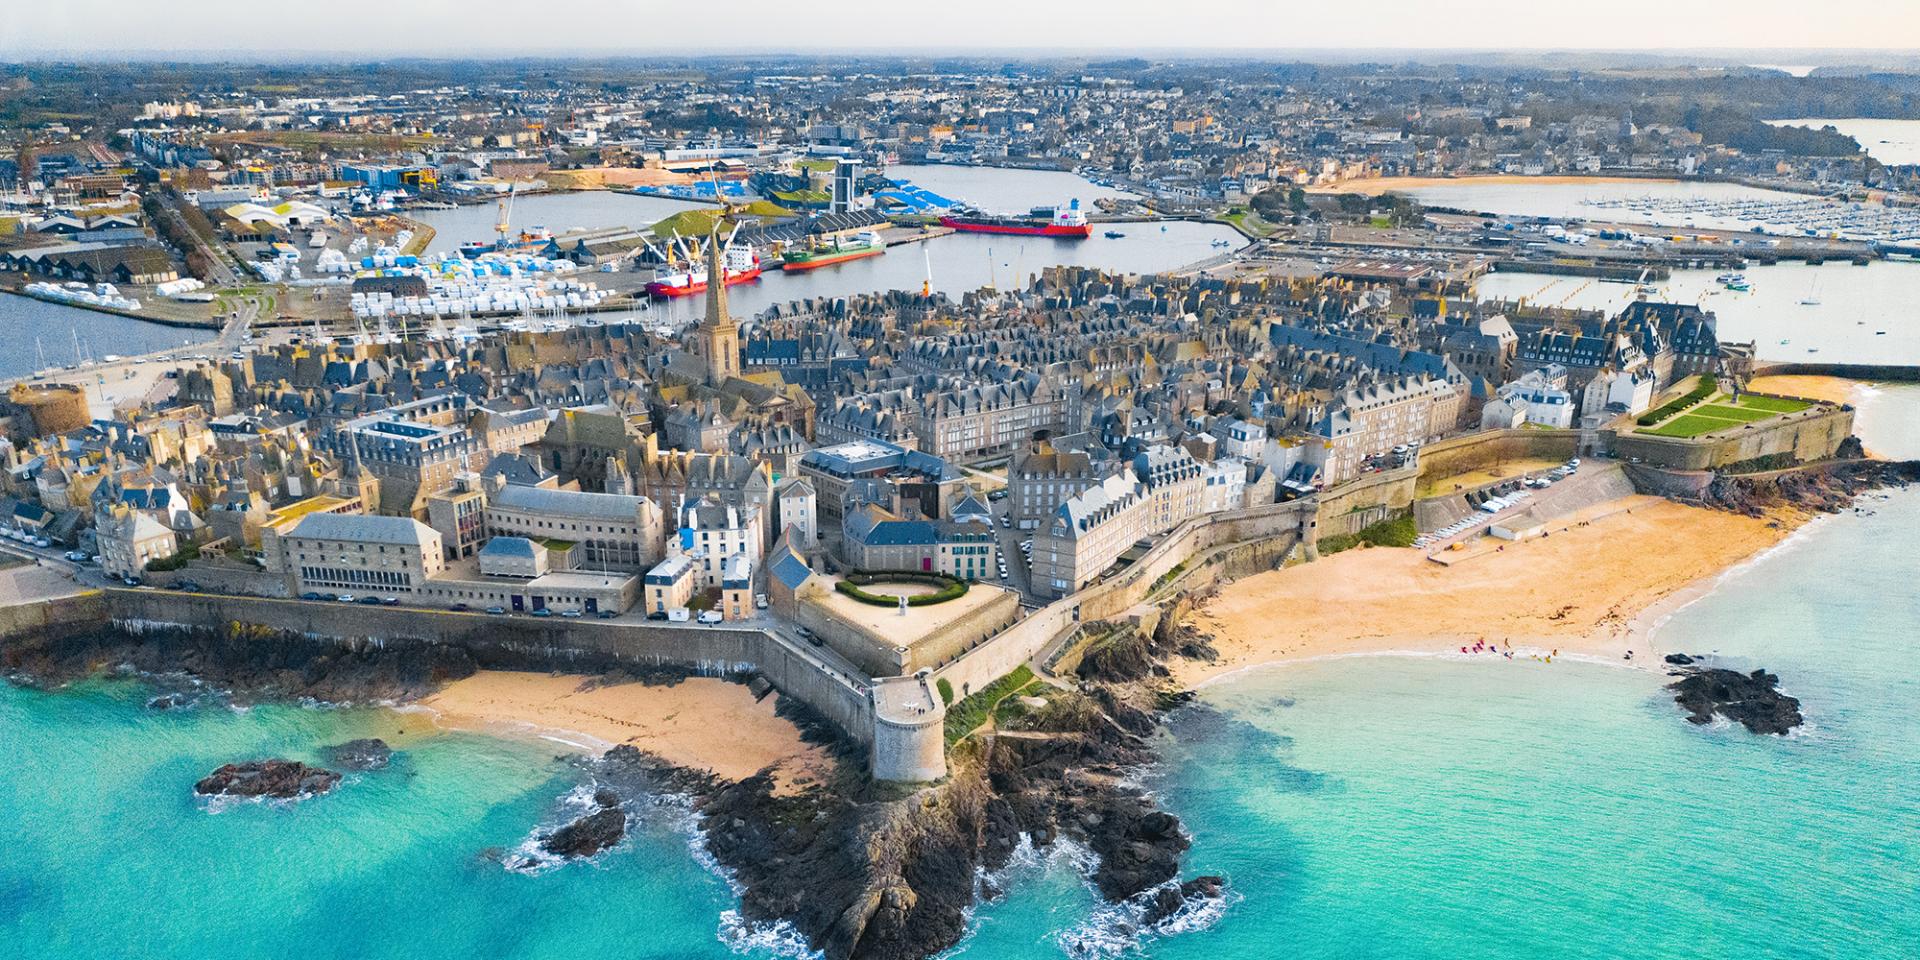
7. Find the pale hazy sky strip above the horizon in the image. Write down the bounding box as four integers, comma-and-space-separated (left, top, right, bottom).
0, 0, 1920, 60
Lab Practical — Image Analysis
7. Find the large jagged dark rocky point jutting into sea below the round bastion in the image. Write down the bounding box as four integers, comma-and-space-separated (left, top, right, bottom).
697, 668, 1198, 960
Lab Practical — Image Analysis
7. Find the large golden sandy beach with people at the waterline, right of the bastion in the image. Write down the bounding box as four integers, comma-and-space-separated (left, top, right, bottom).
1175, 495, 1795, 687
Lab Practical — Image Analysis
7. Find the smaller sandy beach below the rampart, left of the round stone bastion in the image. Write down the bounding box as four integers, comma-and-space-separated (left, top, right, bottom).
420, 670, 831, 793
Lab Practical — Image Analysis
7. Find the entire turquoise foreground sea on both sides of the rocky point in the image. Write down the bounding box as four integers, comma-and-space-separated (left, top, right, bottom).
0, 490, 1920, 960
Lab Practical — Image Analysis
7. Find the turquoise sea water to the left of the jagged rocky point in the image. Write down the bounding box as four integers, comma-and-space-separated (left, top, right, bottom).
0, 684, 764, 960
